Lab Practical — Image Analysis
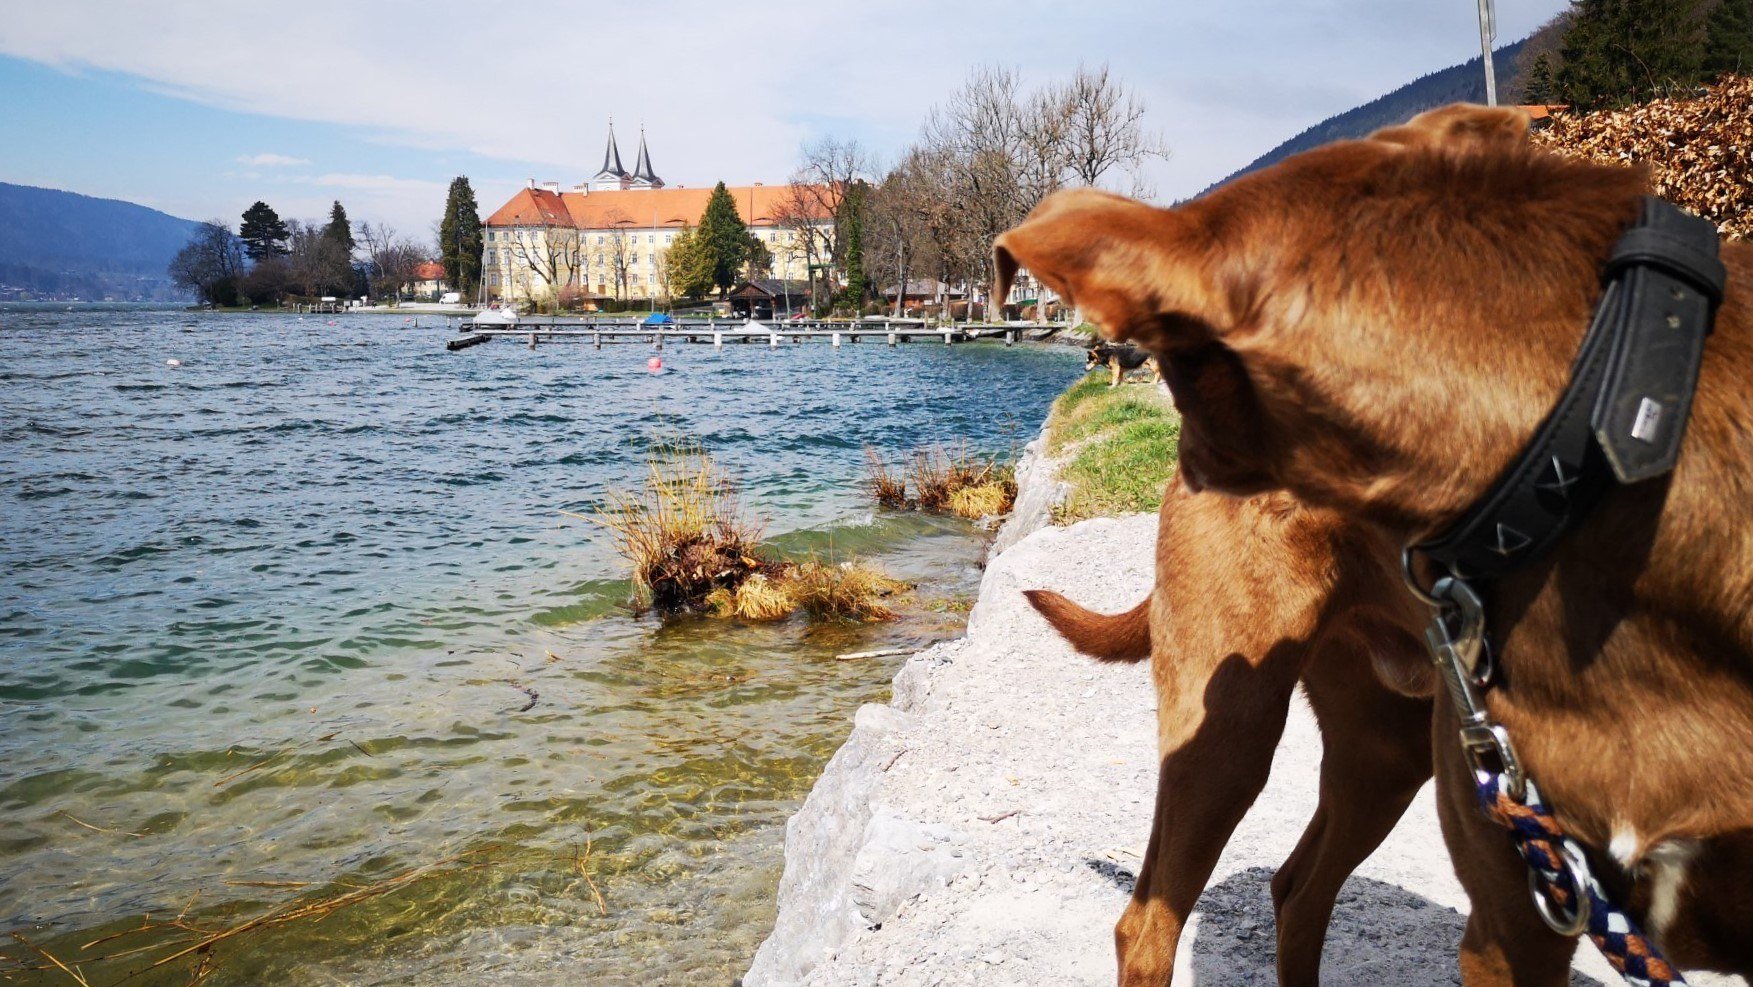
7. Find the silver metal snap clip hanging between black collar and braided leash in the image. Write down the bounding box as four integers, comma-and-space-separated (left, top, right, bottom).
1425, 577, 1527, 801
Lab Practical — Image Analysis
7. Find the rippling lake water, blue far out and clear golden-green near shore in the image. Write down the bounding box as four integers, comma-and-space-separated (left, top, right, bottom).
0, 310, 1078, 983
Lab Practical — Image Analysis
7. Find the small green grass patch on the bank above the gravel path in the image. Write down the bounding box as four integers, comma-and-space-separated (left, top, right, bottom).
1047, 370, 1182, 522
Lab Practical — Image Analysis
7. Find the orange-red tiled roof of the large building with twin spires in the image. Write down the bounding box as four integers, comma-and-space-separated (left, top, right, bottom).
487, 186, 827, 230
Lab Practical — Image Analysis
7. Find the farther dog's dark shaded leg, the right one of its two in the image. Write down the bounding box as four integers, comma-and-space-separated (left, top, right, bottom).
1273, 640, 1430, 987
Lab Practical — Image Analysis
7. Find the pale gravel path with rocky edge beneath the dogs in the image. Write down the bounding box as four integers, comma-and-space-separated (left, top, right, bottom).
743, 440, 1741, 987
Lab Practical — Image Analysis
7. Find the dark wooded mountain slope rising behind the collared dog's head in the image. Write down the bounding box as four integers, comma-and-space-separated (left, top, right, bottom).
1199, 35, 1555, 195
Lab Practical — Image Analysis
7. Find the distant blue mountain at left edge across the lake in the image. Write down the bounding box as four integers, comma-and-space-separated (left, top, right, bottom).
0, 182, 196, 300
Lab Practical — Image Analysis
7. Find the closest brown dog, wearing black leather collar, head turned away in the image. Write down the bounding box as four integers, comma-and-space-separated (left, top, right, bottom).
996, 107, 1753, 985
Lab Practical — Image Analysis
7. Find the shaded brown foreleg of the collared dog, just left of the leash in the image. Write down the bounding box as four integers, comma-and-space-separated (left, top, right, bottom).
1430, 701, 1576, 987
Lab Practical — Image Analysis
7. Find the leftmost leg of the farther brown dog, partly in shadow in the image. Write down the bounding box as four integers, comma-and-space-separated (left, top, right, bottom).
1113, 643, 1302, 987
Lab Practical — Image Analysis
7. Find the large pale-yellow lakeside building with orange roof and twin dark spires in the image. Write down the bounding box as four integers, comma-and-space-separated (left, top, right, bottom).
482, 126, 834, 303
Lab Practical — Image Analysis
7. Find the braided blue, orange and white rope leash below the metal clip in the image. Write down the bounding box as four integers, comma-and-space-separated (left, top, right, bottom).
1474, 771, 1686, 987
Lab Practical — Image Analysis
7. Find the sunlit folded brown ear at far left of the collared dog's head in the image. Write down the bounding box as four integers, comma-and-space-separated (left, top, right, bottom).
992, 189, 1208, 345
